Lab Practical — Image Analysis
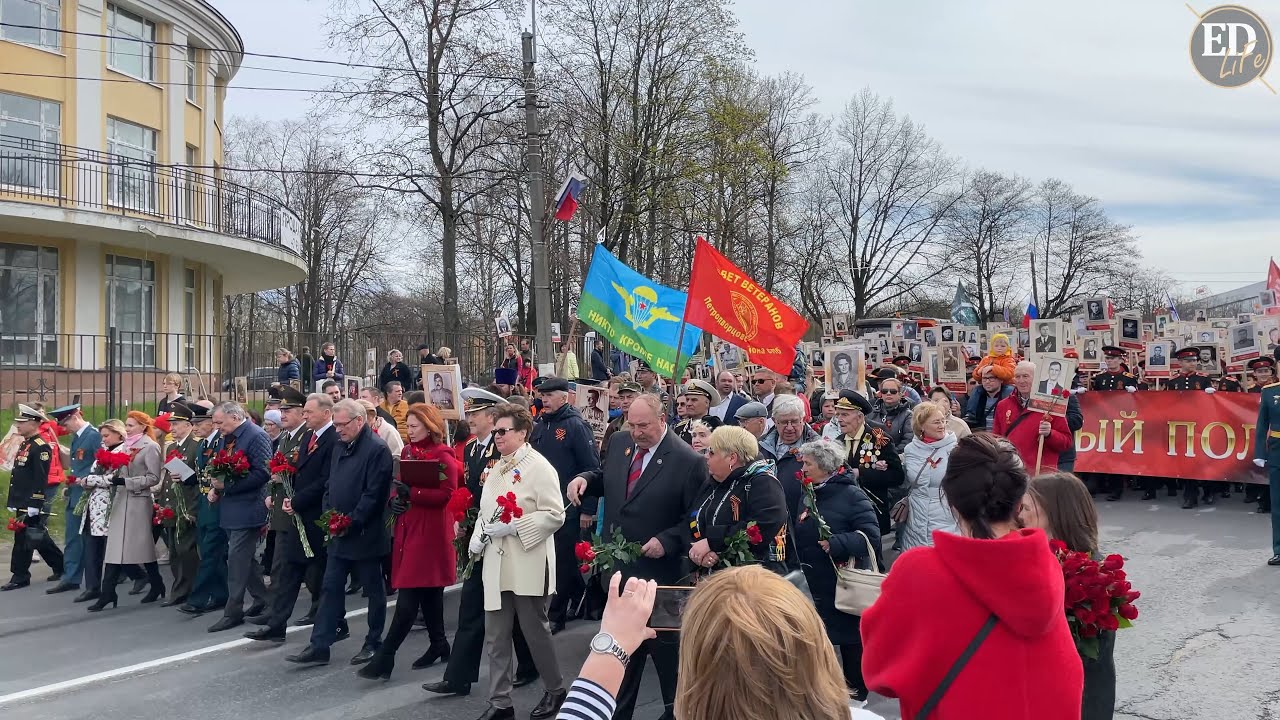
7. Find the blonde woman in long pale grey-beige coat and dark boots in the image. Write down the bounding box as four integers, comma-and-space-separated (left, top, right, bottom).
88, 410, 165, 612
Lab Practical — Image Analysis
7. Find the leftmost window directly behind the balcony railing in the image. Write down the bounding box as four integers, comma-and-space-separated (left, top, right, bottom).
0, 92, 61, 193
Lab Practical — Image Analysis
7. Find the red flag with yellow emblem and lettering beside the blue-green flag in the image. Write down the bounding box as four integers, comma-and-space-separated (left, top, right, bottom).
685, 237, 809, 377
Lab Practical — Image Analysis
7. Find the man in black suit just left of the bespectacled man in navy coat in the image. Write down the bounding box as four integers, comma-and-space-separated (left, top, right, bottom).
244, 392, 349, 642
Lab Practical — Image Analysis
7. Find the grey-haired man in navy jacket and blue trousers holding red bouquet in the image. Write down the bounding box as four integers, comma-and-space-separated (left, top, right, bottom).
209, 402, 271, 633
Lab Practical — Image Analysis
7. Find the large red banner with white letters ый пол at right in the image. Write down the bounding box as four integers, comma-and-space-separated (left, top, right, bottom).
1075, 391, 1267, 483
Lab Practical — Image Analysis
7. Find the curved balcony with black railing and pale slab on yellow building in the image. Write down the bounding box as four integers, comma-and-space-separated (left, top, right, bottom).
0, 135, 306, 295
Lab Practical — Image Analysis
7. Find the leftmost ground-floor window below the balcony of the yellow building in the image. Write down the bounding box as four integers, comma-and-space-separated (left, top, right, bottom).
0, 242, 58, 365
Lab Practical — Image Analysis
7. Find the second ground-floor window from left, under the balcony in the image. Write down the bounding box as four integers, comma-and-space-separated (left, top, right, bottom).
106, 255, 156, 368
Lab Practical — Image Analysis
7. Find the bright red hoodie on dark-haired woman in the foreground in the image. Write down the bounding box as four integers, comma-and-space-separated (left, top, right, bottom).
861, 529, 1084, 720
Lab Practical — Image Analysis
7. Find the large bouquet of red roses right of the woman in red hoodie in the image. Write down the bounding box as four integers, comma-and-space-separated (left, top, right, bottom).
1050, 539, 1142, 660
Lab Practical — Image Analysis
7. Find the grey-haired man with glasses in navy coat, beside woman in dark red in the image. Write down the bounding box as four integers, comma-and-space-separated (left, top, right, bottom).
285, 398, 392, 665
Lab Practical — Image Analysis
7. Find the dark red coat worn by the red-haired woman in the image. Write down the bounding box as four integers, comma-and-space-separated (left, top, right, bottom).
392, 443, 461, 589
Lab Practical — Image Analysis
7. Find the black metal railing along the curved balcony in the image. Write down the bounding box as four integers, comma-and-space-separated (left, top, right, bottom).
0, 135, 302, 255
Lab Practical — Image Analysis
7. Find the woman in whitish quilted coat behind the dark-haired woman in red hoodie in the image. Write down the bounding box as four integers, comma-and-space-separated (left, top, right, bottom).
899, 402, 956, 551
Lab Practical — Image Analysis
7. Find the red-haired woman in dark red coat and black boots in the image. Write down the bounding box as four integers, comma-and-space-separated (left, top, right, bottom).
356, 404, 461, 680
